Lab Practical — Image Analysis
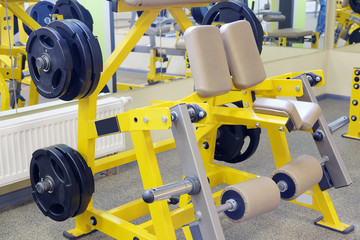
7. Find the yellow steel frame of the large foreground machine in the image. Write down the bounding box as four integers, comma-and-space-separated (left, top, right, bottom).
68, 20, 348, 234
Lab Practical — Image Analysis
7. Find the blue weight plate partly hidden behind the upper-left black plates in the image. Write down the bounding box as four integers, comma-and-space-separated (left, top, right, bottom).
23, 1, 54, 35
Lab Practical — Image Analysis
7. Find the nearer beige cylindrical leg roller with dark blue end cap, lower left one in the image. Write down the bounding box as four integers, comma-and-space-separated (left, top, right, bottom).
221, 177, 280, 222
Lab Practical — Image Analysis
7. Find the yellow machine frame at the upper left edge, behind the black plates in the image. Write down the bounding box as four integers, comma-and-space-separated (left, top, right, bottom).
0, 0, 41, 111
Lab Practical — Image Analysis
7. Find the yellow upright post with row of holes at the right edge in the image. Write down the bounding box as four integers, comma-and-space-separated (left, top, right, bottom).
343, 68, 360, 140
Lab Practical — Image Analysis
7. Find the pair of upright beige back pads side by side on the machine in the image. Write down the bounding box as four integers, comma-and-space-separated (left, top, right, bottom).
184, 20, 266, 97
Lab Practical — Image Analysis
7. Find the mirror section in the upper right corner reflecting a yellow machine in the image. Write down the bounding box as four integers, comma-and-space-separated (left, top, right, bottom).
334, 0, 360, 52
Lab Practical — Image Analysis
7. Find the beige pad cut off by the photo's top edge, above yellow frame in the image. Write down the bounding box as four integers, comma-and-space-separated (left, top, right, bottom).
125, 0, 224, 7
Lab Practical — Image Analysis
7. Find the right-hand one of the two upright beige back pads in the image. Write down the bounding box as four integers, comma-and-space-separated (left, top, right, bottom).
220, 20, 266, 89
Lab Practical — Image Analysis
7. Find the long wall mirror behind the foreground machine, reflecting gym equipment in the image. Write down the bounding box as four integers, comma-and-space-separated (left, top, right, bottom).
0, 0, 326, 111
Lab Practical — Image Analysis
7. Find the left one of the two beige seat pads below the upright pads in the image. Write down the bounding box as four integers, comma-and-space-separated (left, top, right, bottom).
252, 98, 303, 130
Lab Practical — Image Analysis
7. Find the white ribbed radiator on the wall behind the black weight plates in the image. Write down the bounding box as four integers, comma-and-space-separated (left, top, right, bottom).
0, 98, 129, 187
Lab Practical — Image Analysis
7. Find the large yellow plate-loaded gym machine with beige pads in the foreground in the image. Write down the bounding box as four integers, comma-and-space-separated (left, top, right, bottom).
28, 0, 354, 239
